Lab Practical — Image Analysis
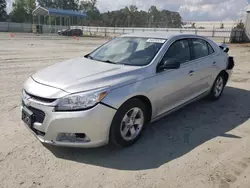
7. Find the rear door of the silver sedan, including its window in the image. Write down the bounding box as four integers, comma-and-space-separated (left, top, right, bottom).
190, 38, 217, 93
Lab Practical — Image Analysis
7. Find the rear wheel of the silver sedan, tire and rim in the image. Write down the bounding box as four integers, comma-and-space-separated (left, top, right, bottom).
209, 74, 226, 100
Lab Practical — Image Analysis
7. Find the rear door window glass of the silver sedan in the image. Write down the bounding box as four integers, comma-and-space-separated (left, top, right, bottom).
192, 39, 209, 59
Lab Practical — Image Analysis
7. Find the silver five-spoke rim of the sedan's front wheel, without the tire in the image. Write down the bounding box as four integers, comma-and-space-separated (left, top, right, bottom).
120, 107, 144, 141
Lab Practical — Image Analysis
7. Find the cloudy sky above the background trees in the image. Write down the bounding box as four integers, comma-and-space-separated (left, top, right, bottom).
4, 0, 250, 21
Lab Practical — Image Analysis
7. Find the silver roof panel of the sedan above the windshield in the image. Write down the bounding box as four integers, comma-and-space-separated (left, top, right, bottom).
121, 31, 202, 39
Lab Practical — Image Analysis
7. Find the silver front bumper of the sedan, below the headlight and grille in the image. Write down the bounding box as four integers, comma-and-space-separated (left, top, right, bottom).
21, 102, 116, 148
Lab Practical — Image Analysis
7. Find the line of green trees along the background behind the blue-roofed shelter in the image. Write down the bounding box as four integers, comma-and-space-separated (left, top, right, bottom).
9, 0, 182, 28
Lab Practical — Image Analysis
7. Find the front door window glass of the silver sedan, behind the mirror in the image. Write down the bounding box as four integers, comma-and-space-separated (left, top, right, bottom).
162, 39, 190, 63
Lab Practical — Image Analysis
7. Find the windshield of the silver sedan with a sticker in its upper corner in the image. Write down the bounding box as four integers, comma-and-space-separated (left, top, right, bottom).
87, 37, 166, 66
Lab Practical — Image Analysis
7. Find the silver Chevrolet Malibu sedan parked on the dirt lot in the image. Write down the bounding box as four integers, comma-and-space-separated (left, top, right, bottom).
21, 32, 234, 147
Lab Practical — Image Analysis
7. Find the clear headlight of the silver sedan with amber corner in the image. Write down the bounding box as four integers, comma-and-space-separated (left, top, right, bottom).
55, 89, 108, 111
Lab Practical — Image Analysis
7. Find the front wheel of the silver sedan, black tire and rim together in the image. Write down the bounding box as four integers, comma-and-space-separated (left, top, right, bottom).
110, 99, 148, 147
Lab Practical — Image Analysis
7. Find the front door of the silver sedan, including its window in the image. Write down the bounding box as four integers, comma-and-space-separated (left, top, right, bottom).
154, 39, 197, 116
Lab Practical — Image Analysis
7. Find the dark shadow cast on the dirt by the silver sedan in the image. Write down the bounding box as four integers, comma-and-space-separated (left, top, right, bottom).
46, 87, 250, 170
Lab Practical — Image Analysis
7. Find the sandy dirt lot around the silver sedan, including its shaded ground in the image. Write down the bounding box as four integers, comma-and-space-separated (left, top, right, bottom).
0, 33, 250, 188
